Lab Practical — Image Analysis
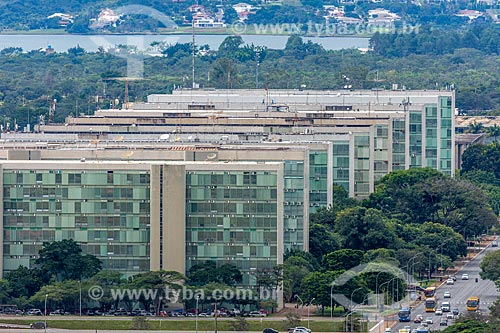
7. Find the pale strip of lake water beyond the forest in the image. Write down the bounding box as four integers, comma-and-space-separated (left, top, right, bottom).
0, 34, 369, 52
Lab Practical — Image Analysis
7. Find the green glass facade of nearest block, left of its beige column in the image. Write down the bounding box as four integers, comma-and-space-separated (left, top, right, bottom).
3, 170, 150, 275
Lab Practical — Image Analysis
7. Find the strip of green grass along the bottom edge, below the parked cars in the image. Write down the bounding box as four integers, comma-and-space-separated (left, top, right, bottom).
0, 317, 343, 332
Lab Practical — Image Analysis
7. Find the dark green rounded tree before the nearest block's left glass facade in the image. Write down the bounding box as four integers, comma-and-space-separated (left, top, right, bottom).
35, 239, 101, 281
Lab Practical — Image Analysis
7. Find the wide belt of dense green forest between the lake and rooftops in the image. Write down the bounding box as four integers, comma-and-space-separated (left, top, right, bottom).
0, 27, 500, 129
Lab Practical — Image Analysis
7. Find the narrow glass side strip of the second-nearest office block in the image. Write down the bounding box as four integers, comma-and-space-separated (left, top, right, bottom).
309, 150, 328, 213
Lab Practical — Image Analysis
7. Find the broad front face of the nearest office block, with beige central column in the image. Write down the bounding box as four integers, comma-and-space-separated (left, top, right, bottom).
0, 160, 284, 285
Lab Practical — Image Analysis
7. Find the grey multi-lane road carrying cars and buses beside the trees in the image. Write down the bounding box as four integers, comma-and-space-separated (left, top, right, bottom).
392, 237, 500, 332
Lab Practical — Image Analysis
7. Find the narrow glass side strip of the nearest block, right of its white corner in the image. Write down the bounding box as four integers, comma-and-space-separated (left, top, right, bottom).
283, 161, 304, 251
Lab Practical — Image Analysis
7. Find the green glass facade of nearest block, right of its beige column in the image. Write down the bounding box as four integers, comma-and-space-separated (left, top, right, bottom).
186, 171, 278, 285
